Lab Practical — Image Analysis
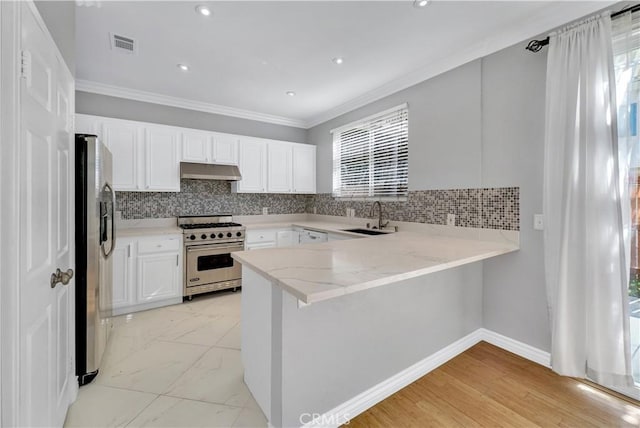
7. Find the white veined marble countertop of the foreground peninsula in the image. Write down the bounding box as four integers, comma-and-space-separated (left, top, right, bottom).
232, 229, 519, 303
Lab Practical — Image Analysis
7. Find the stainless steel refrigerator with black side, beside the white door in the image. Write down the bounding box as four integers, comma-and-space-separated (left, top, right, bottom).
75, 134, 116, 385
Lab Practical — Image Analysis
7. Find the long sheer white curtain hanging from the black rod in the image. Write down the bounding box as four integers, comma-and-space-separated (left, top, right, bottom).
543, 14, 632, 386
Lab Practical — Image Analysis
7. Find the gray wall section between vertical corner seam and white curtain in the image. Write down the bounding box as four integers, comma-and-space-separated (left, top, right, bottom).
482, 44, 551, 351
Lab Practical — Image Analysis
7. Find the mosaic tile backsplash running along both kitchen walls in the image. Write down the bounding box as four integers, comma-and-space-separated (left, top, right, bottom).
116, 180, 520, 230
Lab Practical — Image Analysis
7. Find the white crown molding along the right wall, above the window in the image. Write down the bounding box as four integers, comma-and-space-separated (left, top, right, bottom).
305, 0, 617, 129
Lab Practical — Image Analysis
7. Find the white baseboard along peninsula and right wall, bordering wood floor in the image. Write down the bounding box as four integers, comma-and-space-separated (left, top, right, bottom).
303, 328, 550, 428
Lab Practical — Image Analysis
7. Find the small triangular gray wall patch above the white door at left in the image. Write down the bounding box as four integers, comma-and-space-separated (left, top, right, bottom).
35, 1, 76, 76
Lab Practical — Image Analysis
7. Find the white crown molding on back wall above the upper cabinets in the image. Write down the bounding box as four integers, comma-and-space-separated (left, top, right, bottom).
76, 79, 306, 128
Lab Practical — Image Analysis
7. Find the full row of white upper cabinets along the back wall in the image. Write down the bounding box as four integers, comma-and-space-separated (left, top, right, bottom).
76, 114, 316, 194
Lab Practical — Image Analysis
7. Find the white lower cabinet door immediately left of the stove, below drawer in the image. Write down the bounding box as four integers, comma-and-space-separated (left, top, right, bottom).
137, 253, 182, 303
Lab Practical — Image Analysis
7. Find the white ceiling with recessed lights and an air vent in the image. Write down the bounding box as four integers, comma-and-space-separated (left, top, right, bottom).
76, 1, 613, 128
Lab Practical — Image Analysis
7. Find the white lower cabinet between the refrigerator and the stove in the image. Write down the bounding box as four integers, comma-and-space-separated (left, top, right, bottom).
111, 234, 183, 315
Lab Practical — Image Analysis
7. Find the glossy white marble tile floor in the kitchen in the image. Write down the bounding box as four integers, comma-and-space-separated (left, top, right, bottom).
65, 292, 267, 427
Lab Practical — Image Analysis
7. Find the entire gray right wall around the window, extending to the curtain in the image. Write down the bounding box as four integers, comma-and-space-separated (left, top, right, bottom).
307, 43, 550, 351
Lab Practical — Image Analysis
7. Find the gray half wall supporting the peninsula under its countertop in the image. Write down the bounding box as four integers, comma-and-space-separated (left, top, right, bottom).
278, 263, 482, 427
